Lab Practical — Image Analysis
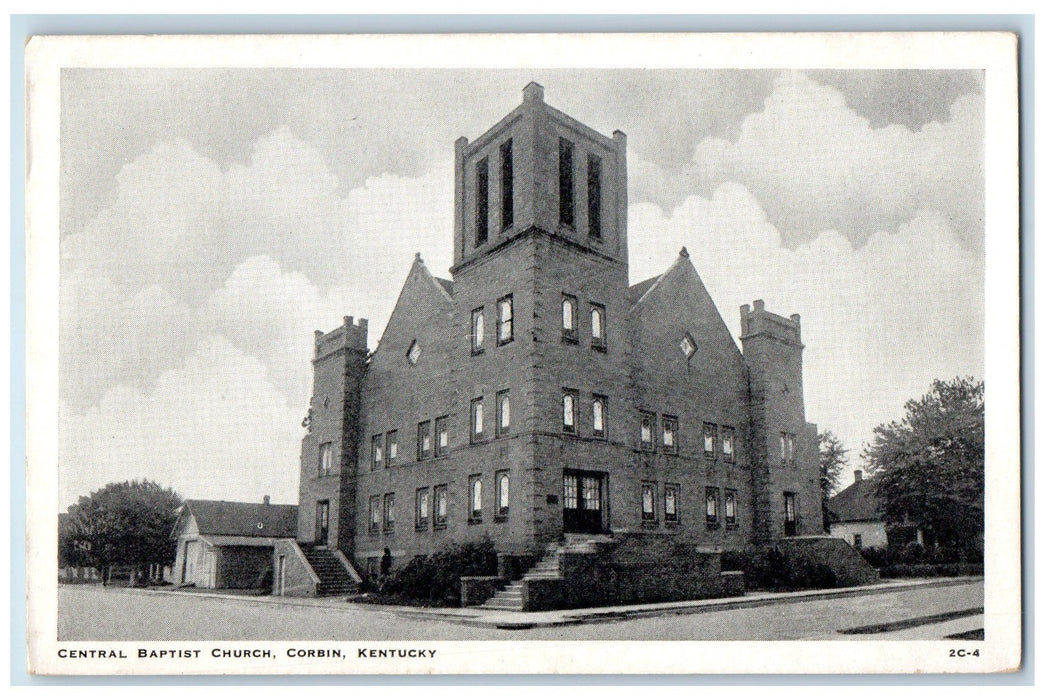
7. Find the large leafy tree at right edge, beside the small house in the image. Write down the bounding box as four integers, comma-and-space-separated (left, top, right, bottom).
863, 377, 983, 557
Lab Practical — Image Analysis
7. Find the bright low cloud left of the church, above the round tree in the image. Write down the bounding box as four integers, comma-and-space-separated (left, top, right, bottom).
59, 335, 303, 506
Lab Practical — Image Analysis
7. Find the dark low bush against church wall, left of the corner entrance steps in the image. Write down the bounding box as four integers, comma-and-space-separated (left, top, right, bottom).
373, 539, 497, 607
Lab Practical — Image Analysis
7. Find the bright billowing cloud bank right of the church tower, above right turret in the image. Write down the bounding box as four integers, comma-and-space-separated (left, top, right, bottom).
629, 183, 984, 458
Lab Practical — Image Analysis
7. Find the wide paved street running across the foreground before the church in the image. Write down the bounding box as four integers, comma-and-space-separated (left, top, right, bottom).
59, 581, 983, 640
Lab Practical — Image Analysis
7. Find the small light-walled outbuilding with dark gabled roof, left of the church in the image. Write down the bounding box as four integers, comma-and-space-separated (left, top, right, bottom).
171, 496, 298, 589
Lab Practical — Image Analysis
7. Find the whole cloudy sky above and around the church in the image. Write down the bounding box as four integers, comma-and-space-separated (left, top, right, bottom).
59, 69, 984, 508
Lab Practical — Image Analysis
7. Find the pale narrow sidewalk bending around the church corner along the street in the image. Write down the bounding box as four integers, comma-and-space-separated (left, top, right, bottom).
127, 577, 982, 630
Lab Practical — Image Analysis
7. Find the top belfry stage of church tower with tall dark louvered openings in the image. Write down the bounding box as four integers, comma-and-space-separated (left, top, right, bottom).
451, 83, 628, 272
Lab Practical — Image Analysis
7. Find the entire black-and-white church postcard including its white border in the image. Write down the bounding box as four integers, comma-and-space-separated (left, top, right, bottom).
26, 32, 1021, 675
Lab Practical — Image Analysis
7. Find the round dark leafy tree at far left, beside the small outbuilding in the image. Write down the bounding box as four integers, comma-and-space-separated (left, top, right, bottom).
59, 480, 182, 571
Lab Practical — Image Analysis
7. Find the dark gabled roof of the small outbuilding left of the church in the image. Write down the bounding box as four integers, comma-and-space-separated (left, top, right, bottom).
175, 499, 298, 537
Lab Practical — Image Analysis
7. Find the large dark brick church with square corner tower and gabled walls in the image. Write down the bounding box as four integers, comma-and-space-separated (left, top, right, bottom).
290, 83, 821, 575
